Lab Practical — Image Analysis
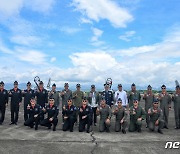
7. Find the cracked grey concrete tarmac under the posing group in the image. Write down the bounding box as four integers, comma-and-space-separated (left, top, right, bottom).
0, 99, 180, 154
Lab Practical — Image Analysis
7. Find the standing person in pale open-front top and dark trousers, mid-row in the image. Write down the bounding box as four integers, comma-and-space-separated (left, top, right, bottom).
88, 85, 99, 126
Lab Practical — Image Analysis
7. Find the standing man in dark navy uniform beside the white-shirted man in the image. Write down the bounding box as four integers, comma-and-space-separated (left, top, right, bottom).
102, 83, 114, 107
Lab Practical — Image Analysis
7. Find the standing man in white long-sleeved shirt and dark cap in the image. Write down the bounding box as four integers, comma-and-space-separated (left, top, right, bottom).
114, 84, 128, 107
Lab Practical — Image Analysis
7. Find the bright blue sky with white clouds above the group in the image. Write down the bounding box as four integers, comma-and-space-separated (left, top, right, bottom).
0, 0, 180, 89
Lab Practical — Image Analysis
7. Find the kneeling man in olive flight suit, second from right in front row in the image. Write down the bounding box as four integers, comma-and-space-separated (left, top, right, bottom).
129, 99, 146, 132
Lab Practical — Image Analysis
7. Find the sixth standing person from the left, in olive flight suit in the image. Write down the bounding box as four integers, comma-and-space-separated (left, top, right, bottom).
60, 83, 72, 107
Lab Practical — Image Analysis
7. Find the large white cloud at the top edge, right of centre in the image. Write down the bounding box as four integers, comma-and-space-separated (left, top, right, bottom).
72, 0, 133, 27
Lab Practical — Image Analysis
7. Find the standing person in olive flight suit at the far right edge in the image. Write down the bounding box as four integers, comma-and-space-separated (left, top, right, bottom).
172, 85, 180, 129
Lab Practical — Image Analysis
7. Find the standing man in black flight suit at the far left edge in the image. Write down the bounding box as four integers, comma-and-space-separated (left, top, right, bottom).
0, 81, 9, 125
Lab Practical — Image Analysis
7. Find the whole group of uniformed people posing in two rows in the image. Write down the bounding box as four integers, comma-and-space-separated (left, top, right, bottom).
0, 81, 180, 134
